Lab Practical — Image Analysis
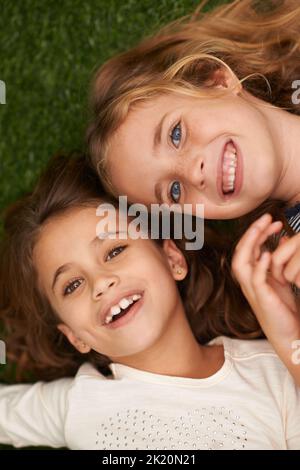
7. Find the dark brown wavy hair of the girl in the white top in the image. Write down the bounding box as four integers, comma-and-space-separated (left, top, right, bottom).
0, 154, 268, 381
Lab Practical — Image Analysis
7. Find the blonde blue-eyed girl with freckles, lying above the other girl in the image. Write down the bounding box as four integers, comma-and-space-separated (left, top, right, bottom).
87, 0, 300, 294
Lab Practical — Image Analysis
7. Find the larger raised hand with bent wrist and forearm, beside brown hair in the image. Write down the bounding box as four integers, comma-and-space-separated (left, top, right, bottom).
232, 214, 300, 383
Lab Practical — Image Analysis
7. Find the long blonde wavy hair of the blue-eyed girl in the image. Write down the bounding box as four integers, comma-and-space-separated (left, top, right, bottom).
86, 0, 300, 196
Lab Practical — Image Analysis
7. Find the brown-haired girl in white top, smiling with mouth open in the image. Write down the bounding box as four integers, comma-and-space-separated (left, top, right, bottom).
0, 151, 300, 450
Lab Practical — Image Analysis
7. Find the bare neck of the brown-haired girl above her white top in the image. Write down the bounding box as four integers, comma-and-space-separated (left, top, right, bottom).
111, 307, 224, 378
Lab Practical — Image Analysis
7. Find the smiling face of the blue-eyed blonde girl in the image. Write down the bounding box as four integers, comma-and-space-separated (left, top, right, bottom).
107, 90, 280, 219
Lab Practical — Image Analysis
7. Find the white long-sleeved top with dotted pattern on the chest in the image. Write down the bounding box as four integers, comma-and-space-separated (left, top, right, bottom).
0, 337, 300, 450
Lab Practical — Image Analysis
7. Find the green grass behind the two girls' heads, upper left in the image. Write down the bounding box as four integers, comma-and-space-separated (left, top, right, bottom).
0, 0, 229, 448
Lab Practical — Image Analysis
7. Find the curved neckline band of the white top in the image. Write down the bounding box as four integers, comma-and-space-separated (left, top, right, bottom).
109, 336, 232, 388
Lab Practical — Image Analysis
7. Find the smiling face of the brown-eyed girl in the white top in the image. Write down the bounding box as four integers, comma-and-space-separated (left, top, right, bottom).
33, 207, 187, 358
